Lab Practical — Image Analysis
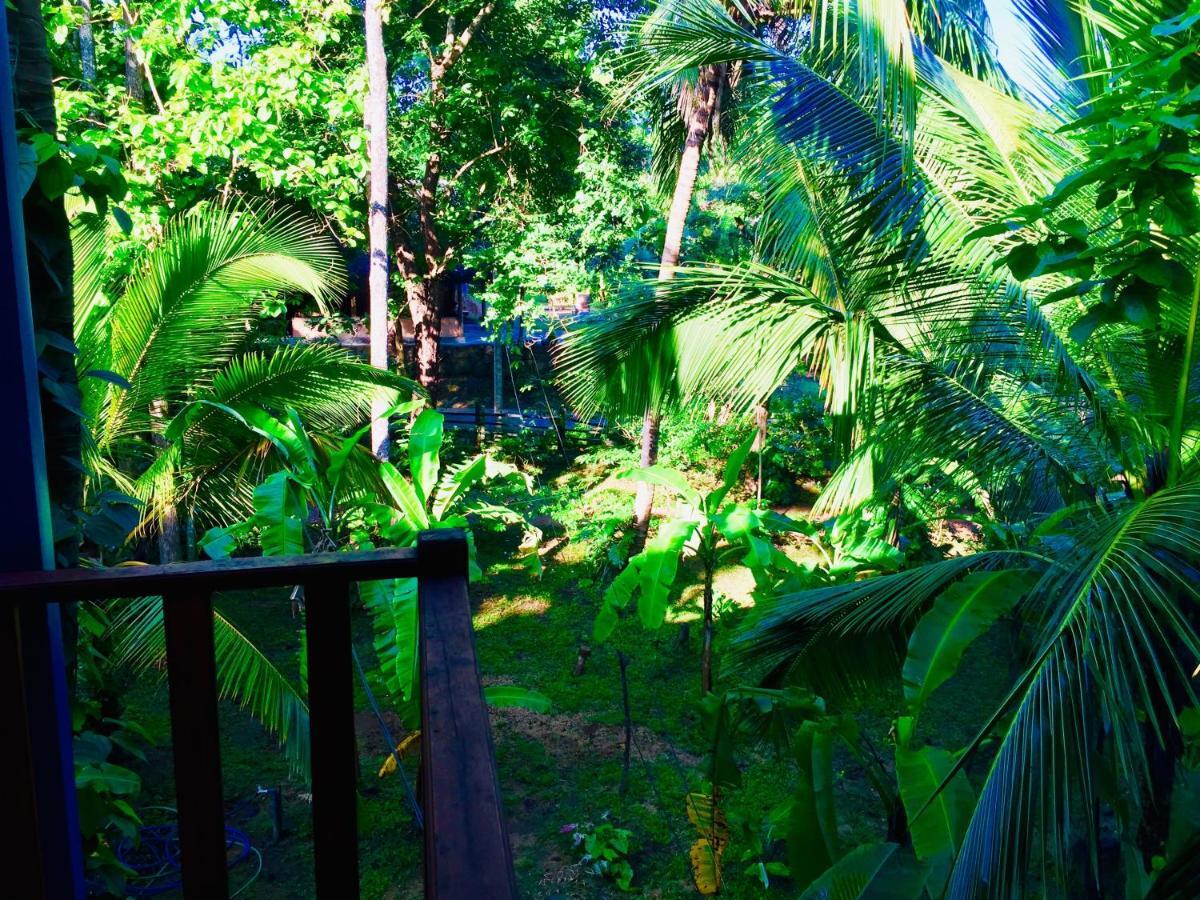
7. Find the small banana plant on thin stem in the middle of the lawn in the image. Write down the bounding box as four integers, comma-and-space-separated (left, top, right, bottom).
593, 436, 816, 694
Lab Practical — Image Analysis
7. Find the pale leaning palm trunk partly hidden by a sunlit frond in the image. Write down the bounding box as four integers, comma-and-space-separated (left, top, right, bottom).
634, 65, 725, 546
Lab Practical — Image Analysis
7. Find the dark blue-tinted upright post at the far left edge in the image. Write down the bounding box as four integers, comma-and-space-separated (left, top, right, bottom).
0, 10, 84, 898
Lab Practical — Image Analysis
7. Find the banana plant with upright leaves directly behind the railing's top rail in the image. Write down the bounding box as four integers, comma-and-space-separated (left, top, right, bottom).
198, 401, 541, 714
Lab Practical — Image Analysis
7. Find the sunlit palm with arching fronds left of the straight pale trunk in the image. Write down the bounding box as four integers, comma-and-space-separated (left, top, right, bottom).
74, 203, 412, 547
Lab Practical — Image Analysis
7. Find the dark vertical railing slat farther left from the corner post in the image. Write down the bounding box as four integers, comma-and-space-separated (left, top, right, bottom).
163, 586, 229, 899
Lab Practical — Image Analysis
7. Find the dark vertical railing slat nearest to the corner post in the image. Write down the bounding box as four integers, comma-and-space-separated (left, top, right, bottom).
304, 578, 359, 899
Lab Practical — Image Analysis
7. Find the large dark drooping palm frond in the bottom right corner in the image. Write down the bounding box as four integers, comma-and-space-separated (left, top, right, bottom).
948, 481, 1200, 896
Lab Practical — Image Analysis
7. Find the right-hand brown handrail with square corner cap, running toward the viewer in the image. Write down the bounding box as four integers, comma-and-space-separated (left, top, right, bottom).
418, 530, 517, 900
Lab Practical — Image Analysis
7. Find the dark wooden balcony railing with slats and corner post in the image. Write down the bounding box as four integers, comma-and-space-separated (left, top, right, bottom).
0, 530, 516, 900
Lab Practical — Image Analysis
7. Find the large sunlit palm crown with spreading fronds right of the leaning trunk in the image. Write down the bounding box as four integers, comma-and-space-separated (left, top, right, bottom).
559, 5, 1072, 494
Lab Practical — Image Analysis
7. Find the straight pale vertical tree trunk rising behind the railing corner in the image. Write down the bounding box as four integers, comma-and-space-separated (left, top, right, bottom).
364, 0, 388, 460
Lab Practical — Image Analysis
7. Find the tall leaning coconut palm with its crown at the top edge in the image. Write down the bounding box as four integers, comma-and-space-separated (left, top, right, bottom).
588, 0, 1060, 540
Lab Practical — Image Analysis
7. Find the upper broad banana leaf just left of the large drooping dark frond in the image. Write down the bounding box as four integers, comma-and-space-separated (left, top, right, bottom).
902, 569, 1030, 712
